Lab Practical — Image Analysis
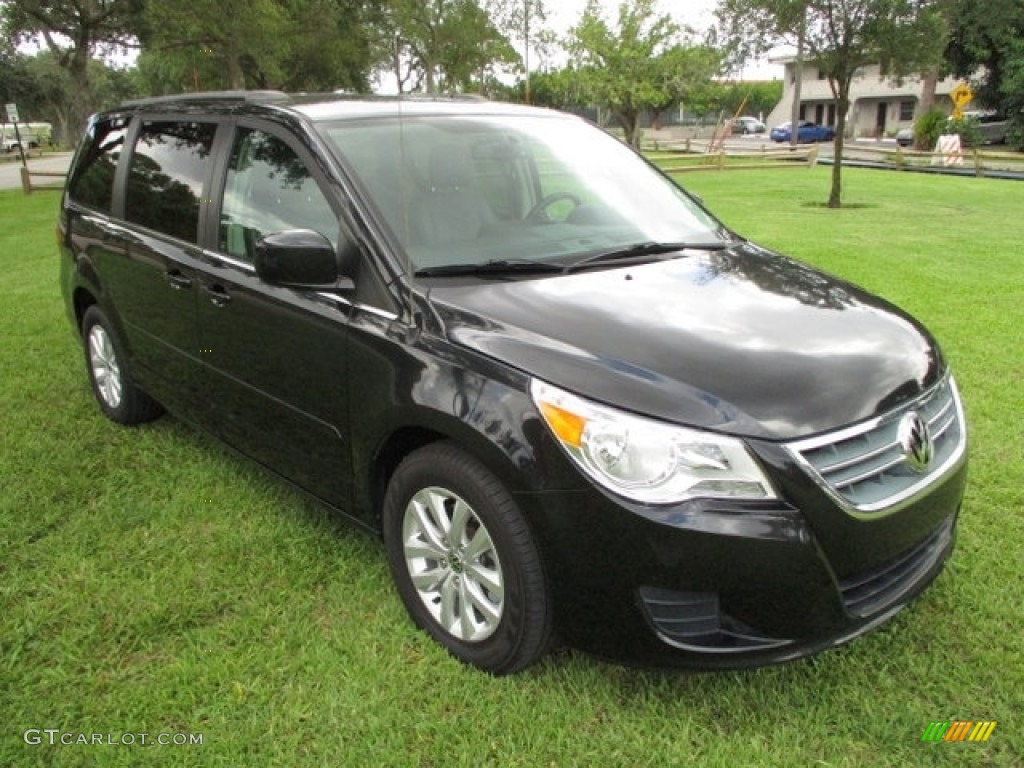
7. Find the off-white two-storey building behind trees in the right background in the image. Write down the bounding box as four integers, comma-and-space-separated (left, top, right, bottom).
766, 57, 961, 138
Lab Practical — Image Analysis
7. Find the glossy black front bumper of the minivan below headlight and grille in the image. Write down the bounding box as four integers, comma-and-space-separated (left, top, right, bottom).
520, 454, 967, 669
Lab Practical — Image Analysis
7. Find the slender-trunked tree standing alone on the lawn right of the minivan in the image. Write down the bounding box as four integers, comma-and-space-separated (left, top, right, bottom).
718, 0, 946, 208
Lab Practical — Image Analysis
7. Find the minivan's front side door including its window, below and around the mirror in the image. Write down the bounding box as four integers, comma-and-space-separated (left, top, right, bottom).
198, 121, 351, 507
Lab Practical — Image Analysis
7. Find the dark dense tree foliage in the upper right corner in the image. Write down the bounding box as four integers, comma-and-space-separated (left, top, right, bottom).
946, 0, 1024, 146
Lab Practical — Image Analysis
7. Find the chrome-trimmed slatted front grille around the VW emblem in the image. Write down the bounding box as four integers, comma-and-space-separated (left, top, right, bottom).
788, 377, 967, 515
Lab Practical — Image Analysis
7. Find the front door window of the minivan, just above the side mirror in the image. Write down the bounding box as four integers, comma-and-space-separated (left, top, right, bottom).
218, 128, 338, 263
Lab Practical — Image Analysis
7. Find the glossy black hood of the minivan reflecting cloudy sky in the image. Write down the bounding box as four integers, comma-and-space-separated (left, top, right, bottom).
423, 244, 943, 439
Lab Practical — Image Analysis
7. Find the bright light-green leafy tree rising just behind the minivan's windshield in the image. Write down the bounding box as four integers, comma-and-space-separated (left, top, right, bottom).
566, 0, 717, 145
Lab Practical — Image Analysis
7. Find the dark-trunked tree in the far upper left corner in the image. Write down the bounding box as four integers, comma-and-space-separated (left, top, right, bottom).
0, 0, 142, 138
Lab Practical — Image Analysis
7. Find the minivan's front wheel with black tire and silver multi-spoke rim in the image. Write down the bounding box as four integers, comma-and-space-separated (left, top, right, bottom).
382, 442, 552, 675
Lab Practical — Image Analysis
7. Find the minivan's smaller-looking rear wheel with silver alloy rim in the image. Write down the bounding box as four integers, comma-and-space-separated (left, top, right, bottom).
82, 306, 164, 425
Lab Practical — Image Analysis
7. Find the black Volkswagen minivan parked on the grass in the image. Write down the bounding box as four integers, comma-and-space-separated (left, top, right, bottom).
58, 91, 967, 674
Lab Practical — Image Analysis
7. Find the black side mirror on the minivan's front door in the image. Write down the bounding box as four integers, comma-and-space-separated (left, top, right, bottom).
253, 229, 353, 290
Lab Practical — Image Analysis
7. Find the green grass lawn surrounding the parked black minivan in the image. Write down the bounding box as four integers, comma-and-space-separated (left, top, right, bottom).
0, 168, 1024, 768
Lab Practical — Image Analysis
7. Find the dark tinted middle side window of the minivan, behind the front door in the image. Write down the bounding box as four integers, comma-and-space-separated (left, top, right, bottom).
125, 122, 216, 243
